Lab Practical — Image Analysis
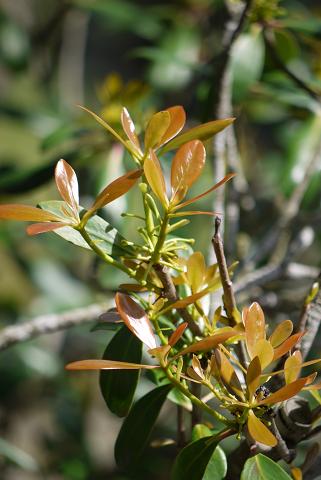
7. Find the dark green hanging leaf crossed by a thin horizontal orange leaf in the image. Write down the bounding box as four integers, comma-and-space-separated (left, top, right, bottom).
99, 326, 142, 417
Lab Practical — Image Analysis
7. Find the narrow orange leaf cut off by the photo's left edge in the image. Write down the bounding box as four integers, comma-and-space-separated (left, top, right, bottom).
0, 203, 61, 222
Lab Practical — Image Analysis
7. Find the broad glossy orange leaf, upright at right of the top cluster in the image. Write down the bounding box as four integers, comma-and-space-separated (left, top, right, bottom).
171, 140, 206, 205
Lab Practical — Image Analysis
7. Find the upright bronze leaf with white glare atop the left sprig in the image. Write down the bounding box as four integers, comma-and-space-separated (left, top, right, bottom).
55, 159, 79, 218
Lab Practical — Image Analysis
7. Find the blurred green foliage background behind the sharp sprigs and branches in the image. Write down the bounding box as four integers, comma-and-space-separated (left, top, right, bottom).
0, 0, 321, 480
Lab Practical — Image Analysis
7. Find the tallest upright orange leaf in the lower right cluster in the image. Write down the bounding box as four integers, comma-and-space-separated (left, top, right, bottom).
243, 302, 265, 360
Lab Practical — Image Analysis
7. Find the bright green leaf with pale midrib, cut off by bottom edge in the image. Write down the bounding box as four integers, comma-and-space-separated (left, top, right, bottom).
241, 453, 291, 480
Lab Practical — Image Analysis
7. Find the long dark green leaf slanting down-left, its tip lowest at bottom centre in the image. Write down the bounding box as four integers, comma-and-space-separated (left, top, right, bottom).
115, 384, 172, 470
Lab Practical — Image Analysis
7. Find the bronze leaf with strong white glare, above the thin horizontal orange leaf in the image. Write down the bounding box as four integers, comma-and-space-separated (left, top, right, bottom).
115, 293, 157, 349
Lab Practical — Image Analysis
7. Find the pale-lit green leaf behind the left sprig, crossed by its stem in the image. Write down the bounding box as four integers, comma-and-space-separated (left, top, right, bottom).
40, 200, 133, 257
